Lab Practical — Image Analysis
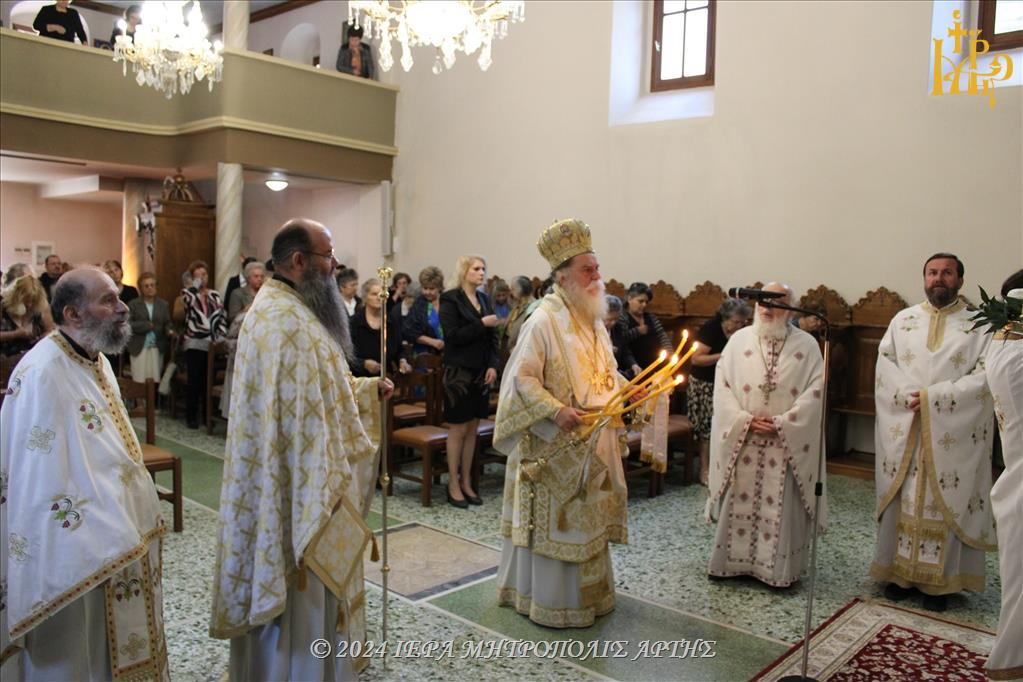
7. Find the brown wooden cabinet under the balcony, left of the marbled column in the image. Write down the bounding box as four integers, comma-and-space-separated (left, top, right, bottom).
153, 201, 217, 305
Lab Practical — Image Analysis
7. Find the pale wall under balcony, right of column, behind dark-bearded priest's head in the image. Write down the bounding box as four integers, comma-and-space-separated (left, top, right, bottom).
241, 183, 383, 279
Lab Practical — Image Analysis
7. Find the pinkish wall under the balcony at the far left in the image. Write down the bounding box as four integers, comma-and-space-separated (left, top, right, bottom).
0, 182, 122, 274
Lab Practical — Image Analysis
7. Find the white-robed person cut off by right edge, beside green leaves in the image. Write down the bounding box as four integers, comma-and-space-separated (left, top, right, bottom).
984, 270, 1023, 680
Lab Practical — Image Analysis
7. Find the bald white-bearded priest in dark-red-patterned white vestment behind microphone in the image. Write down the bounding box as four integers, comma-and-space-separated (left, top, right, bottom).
707, 282, 827, 587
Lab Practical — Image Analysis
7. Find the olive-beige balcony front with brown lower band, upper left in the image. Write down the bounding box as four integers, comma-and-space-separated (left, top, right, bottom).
0, 29, 398, 182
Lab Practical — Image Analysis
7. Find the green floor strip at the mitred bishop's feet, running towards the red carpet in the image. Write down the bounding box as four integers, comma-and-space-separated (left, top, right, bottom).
429, 580, 789, 680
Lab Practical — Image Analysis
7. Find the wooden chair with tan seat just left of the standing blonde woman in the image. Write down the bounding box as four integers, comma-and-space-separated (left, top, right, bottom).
385, 371, 448, 507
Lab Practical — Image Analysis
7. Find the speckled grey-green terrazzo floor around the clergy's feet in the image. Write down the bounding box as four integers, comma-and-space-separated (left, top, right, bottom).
144, 416, 1000, 680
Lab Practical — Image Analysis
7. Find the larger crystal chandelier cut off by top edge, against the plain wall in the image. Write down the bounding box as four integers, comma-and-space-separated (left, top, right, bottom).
348, 0, 526, 74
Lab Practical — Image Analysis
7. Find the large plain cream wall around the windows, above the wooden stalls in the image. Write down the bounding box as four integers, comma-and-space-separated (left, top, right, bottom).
387, 1, 1023, 304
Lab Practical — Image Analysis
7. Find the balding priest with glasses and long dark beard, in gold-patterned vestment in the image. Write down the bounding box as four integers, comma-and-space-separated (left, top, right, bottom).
210, 219, 393, 682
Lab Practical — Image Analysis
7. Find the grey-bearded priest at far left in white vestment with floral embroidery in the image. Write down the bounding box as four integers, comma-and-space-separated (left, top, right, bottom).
0, 268, 168, 682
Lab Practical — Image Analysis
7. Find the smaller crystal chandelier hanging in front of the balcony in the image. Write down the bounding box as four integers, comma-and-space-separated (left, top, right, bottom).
114, 0, 224, 99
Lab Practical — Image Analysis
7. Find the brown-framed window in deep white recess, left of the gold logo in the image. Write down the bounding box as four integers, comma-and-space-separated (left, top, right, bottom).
650, 0, 717, 92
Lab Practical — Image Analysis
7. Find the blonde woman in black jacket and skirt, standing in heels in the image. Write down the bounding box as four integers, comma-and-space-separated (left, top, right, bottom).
441, 256, 499, 508
